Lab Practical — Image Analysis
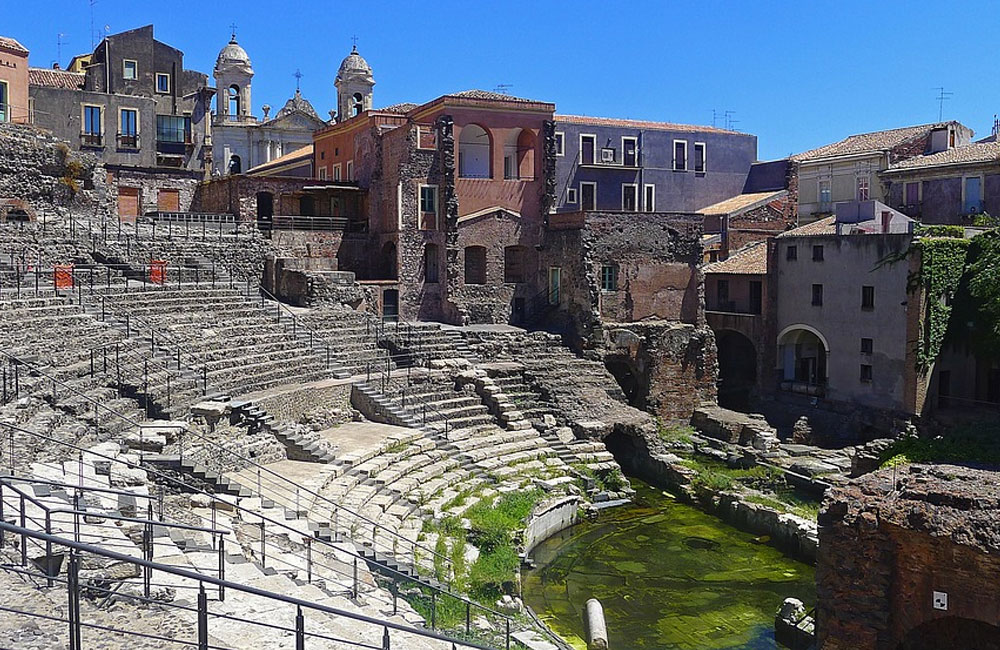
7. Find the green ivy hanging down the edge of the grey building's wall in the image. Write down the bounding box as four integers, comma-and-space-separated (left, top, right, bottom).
911, 237, 969, 372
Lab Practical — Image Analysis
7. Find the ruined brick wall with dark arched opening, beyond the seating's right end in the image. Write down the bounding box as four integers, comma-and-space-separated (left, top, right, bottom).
603, 322, 718, 421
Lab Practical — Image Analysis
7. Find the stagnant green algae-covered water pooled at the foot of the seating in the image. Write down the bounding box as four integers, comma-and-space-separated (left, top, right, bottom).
523, 480, 815, 650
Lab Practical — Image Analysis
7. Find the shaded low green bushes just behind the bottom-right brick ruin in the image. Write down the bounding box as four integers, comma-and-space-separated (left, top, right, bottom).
880, 422, 1000, 467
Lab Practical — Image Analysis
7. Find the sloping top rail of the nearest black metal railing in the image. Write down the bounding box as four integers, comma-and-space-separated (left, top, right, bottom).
0, 521, 500, 650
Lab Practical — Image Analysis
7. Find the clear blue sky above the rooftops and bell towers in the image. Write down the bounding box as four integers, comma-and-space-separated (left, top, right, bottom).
7, 0, 1000, 160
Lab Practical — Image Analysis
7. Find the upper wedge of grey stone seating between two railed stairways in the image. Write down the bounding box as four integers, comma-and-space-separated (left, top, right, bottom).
98, 285, 332, 396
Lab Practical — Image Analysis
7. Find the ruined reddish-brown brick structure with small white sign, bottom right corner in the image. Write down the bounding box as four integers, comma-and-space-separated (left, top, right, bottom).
816, 465, 1000, 650
